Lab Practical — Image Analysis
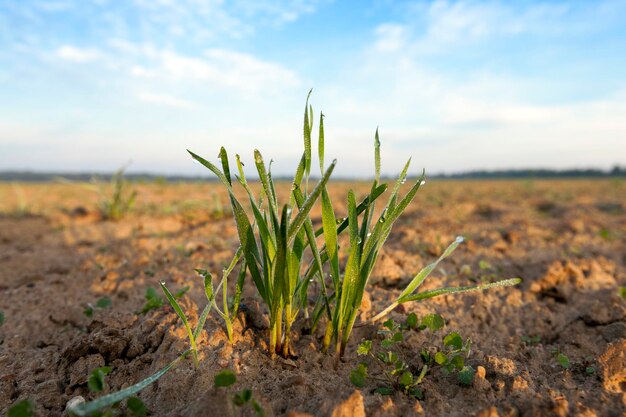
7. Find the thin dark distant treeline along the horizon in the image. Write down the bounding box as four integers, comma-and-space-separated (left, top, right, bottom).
0, 166, 626, 182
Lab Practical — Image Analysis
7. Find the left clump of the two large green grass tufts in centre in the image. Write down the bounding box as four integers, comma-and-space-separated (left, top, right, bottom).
188, 92, 336, 356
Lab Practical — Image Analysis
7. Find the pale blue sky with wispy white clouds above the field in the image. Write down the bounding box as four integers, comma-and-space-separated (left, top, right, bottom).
0, 0, 626, 177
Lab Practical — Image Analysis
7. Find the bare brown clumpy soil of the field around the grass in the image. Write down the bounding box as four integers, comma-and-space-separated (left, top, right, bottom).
0, 180, 626, 417
